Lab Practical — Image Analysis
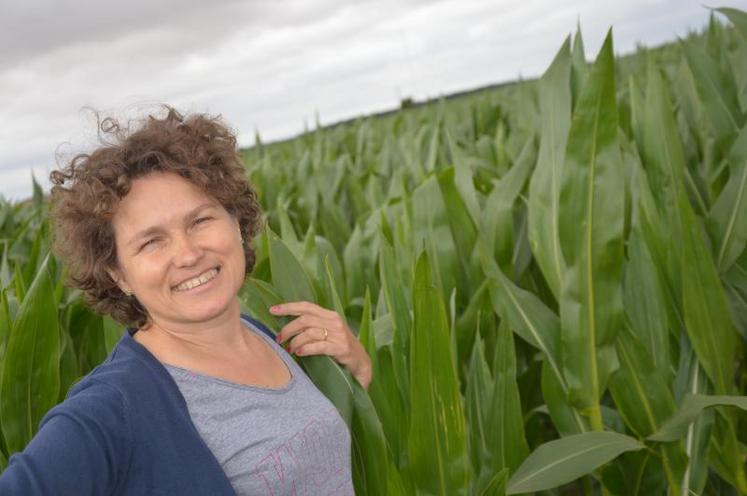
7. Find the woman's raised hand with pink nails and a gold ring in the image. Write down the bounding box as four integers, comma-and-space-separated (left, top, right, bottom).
270, 301, 372, 389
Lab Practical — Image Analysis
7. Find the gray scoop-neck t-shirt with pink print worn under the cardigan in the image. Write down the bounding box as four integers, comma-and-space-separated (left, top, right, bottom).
164, 322, 354, 496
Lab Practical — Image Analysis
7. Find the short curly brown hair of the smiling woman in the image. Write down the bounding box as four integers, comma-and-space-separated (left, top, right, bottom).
50, 107, 261, 327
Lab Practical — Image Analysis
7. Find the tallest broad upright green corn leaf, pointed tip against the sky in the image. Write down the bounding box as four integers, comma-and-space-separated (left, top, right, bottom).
559, 33, 625, 430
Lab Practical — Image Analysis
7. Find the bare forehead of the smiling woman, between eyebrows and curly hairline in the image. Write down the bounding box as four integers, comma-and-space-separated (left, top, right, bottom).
112, 172, 217, 234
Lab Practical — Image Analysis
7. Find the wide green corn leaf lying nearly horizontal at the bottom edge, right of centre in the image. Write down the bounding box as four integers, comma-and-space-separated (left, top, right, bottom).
506, 432, 644, 494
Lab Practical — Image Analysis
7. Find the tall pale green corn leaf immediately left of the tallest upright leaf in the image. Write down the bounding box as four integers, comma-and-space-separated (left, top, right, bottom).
529, 39, 571, 300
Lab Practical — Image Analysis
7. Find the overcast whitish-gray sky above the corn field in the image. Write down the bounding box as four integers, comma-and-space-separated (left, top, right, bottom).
0, 0, 747, 199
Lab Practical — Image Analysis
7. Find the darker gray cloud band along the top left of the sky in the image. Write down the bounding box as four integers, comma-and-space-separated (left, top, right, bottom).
0, 0, 354, 68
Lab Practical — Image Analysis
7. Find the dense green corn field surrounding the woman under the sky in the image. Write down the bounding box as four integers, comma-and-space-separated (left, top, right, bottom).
0, 9, 747, 496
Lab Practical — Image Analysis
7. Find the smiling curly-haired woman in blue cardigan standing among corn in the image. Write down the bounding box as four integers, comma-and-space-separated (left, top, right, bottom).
0, 109, 371, 495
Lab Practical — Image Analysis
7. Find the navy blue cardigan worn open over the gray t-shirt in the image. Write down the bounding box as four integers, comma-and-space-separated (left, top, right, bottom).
0, 317, 280, 496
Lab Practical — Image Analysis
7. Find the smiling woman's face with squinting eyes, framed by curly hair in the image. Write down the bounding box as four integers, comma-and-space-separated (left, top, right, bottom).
112, 172, 245, 327
